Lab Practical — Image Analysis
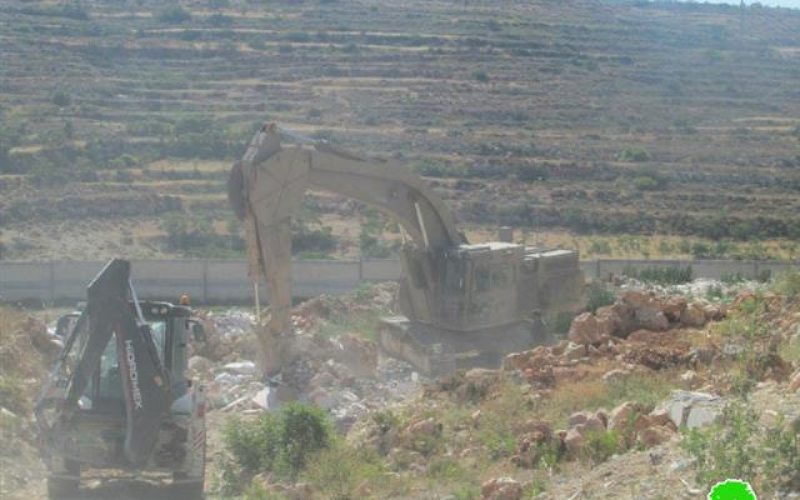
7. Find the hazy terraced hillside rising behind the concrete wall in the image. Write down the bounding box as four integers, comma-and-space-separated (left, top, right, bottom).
0, 0, 800, 259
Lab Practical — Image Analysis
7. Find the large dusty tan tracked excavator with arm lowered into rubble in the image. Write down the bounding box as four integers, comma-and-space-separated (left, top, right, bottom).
228, 124, 584, 375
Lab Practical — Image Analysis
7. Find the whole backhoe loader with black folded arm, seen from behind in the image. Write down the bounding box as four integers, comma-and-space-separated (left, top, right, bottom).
35, 259, 205, 498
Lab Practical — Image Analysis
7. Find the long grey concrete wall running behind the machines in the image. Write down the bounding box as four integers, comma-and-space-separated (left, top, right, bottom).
0, 260, 800, 304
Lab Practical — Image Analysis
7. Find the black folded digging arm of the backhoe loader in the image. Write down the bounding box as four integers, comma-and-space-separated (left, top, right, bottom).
36, 259, 172, 466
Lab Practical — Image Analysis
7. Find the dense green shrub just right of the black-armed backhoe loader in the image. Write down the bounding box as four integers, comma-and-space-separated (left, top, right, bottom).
223, 403, 333, 488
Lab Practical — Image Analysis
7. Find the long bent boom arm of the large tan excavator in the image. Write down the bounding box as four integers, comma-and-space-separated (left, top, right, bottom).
228, 125, 466, 373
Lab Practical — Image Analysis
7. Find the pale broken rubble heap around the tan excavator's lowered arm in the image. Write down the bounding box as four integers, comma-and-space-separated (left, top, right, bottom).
189, 284, 420, 430
